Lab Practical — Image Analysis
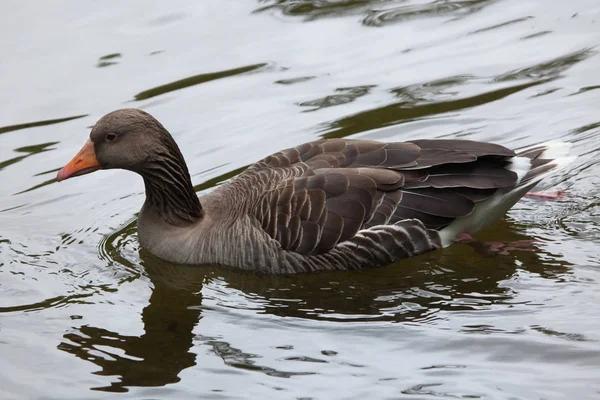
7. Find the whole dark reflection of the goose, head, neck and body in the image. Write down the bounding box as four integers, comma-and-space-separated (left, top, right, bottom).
58, 217, 568, 392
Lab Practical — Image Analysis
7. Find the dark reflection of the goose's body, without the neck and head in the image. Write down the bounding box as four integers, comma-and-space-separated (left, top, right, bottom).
200, 217, 569, 323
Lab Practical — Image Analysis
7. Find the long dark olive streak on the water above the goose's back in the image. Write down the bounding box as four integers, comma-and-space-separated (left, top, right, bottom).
322, 49, 594, 138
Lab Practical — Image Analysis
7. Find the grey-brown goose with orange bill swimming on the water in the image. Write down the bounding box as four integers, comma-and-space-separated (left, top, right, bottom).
57, 109, 571, 273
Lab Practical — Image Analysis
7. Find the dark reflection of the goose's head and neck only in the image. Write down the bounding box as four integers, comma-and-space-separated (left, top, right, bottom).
58, 256, 202, 392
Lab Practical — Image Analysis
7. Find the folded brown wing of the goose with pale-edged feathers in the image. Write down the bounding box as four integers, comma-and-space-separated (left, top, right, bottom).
244, 139, 518, 254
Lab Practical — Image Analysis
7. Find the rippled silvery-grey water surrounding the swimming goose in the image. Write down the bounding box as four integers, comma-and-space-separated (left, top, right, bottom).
0, 0, 600, 399
